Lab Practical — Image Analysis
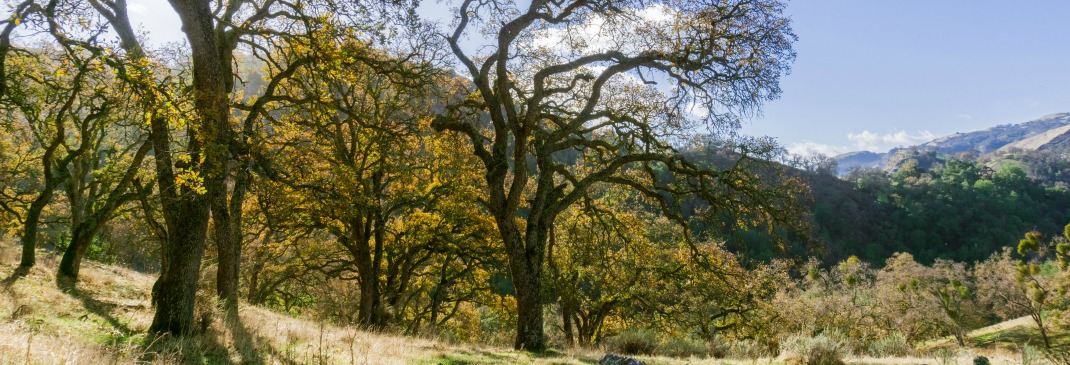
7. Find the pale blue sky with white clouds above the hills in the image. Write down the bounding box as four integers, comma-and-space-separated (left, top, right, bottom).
128, 0, 1070, 155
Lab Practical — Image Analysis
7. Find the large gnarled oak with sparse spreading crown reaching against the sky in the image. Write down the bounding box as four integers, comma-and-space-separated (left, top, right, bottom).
432, 0, 794, 351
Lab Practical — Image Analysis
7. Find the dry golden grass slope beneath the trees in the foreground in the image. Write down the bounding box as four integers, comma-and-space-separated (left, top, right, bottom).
0, 237, 1052, 365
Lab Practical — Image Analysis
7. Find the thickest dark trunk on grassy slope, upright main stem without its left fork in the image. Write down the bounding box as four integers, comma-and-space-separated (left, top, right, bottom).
149, 0, 233, 335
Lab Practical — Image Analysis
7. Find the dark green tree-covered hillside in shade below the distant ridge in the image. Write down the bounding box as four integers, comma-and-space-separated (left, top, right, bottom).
808, 159, 1070, 264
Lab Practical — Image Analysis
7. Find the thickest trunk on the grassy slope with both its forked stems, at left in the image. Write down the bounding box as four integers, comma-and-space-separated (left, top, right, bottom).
91, 0, 218, 335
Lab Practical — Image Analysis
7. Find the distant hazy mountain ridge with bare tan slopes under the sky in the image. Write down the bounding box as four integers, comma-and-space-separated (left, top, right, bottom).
834, 112, 1070, 176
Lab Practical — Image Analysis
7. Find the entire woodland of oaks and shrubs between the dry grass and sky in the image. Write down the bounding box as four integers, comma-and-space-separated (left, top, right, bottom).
0, 0, 1070, 354
